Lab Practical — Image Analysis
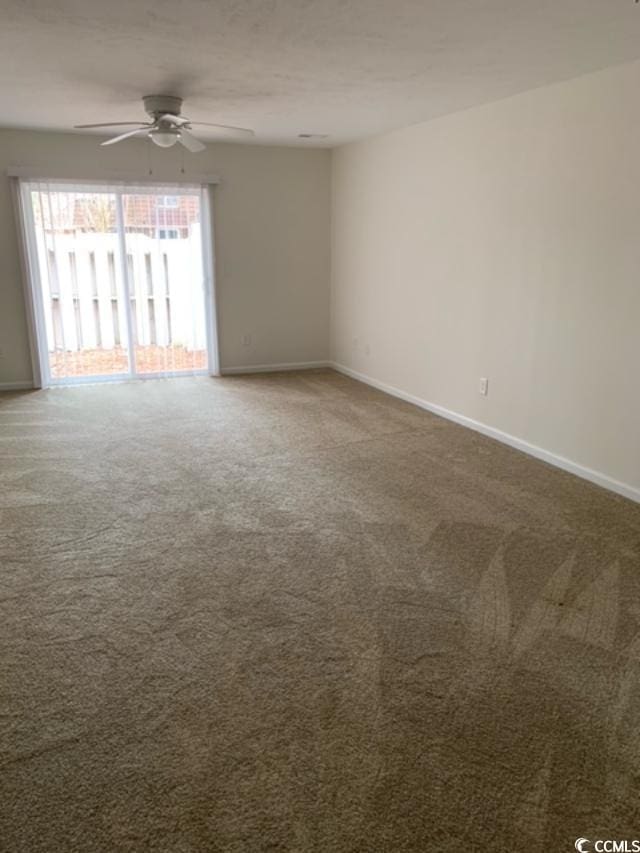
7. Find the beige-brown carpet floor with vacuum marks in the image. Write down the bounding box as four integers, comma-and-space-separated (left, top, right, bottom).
0, 371, 640, 853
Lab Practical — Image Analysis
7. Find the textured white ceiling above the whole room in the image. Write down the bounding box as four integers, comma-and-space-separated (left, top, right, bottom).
0, 0, 640, 145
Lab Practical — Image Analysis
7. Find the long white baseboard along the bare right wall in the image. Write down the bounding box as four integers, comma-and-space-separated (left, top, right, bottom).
330, 362, 640, 503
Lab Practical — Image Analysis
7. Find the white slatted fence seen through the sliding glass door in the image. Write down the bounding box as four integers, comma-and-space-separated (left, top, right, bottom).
36, 224, 206, 351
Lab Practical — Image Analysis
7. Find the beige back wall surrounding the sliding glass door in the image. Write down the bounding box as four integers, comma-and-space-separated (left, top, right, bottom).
0, 130, 330, 384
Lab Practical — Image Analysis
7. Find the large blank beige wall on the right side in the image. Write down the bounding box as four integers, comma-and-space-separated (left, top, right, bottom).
331, 63, 640, 497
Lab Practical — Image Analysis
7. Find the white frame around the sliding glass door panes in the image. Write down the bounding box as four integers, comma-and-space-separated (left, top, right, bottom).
10, 178, 220, 388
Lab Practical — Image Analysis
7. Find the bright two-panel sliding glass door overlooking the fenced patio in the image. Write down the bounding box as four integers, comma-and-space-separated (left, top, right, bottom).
21, 181, 213, 384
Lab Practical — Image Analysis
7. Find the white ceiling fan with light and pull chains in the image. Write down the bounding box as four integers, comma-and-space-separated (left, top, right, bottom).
74, 95, 254, 154
